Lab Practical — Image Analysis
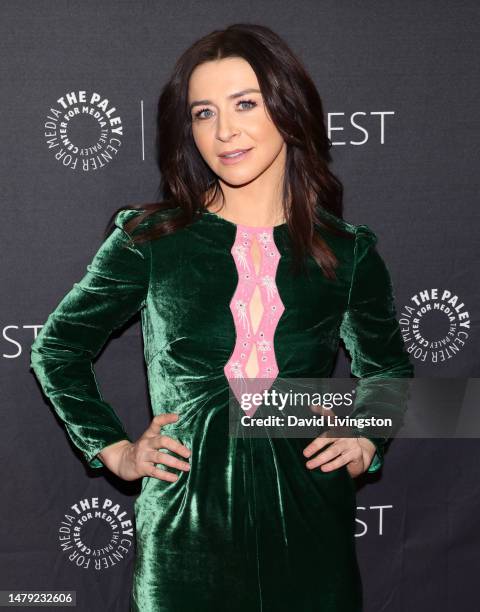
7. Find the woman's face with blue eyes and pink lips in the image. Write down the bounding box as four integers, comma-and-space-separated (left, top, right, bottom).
188, 57, 286, 186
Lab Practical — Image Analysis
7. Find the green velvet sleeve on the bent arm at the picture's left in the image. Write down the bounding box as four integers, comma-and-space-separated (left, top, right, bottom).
30, 209, 150, 468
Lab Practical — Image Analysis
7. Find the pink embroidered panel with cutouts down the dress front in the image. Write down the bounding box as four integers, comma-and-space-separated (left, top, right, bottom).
224, 225, 285, 414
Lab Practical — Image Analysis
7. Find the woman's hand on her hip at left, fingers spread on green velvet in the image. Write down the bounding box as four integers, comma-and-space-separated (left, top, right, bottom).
98, 413, 191, 482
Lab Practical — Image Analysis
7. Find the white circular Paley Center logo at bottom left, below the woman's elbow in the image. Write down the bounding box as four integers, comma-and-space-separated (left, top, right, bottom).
58, 497, 134, 571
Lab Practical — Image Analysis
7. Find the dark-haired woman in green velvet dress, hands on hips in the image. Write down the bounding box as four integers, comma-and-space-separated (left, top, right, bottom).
32, 24, 413, 612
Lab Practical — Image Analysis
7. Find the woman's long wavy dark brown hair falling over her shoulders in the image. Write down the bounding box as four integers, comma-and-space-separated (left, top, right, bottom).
111, 23, 349, 278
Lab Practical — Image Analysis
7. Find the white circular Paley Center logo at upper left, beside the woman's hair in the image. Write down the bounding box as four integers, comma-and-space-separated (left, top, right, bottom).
44, 90, 123, 172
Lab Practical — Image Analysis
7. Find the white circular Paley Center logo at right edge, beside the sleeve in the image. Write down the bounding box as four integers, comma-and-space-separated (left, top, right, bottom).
399, 287, 470, 363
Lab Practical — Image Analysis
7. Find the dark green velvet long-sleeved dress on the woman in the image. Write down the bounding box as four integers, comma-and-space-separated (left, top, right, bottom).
31, 210, 413, 612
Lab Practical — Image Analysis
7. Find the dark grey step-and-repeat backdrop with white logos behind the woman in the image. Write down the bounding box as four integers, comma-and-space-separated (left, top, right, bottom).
0, 0, 480, 612
